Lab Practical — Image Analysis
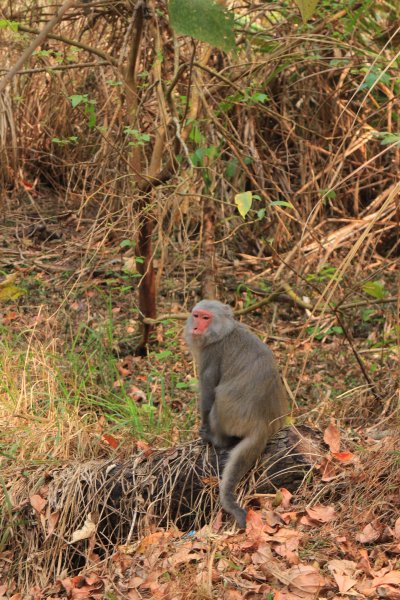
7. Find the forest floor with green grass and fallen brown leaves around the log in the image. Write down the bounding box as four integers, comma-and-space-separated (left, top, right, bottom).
0, 195, 400, 600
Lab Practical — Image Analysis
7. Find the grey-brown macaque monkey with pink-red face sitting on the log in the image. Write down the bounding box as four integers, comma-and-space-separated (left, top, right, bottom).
185, 300, 289, 528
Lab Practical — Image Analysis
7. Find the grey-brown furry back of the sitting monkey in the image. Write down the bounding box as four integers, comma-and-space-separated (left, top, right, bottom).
216, 323, 288, 437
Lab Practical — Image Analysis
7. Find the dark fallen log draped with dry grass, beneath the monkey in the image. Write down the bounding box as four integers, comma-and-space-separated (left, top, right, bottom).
6, 426, 326, 585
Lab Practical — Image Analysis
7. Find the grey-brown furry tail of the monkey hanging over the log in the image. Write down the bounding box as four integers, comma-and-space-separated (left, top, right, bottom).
220, 431, 266, 529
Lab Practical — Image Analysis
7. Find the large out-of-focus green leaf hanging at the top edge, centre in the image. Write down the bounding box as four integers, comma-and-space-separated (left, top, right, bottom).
168, 0, 235, 51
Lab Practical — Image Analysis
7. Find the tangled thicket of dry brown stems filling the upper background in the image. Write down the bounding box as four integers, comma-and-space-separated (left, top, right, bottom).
2, 1, 399, 260
